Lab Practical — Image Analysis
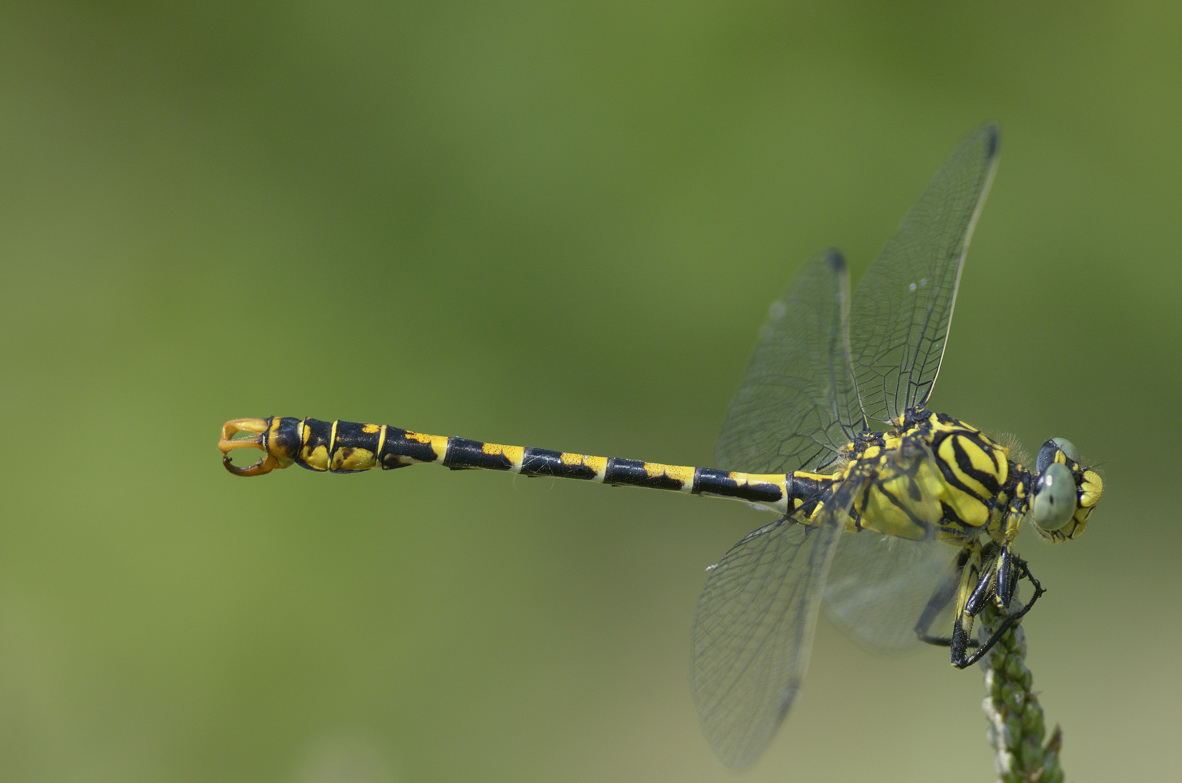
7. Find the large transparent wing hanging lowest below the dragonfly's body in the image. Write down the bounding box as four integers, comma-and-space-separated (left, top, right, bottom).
690, 486, 855, 770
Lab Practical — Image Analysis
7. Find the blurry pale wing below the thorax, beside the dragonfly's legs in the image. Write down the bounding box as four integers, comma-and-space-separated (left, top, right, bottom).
824, 530, 959, 654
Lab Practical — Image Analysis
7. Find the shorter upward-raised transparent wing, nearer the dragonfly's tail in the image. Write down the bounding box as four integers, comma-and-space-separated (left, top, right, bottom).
715, 251, 862, 473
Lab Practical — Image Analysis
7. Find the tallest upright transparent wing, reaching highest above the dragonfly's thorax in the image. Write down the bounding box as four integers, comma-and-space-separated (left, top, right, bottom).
850, 125, 999, 421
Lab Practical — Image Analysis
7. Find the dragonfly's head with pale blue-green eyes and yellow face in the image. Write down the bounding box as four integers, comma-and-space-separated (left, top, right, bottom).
1030, 438, 1104, 543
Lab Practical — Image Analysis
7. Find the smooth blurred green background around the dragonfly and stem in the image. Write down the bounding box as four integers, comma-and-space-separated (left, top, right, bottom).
0, 0, 1182, 783
